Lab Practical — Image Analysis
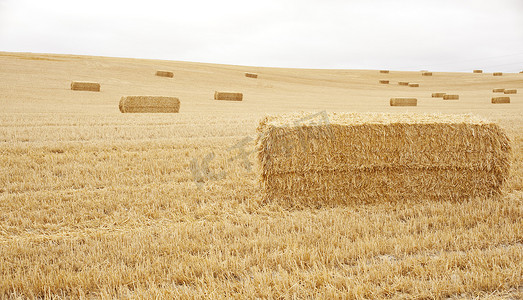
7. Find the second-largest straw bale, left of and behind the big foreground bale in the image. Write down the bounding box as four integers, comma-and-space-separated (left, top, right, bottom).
119, 96, 180, 113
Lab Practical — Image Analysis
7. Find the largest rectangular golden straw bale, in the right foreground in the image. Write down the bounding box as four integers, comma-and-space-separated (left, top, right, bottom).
257, 113, 510, 205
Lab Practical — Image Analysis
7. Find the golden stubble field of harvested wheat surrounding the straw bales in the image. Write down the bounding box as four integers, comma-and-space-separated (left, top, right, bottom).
0, 52, 523, 299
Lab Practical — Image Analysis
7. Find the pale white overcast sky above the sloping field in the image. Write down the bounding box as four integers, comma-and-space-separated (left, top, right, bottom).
0, 0, 523, 72
